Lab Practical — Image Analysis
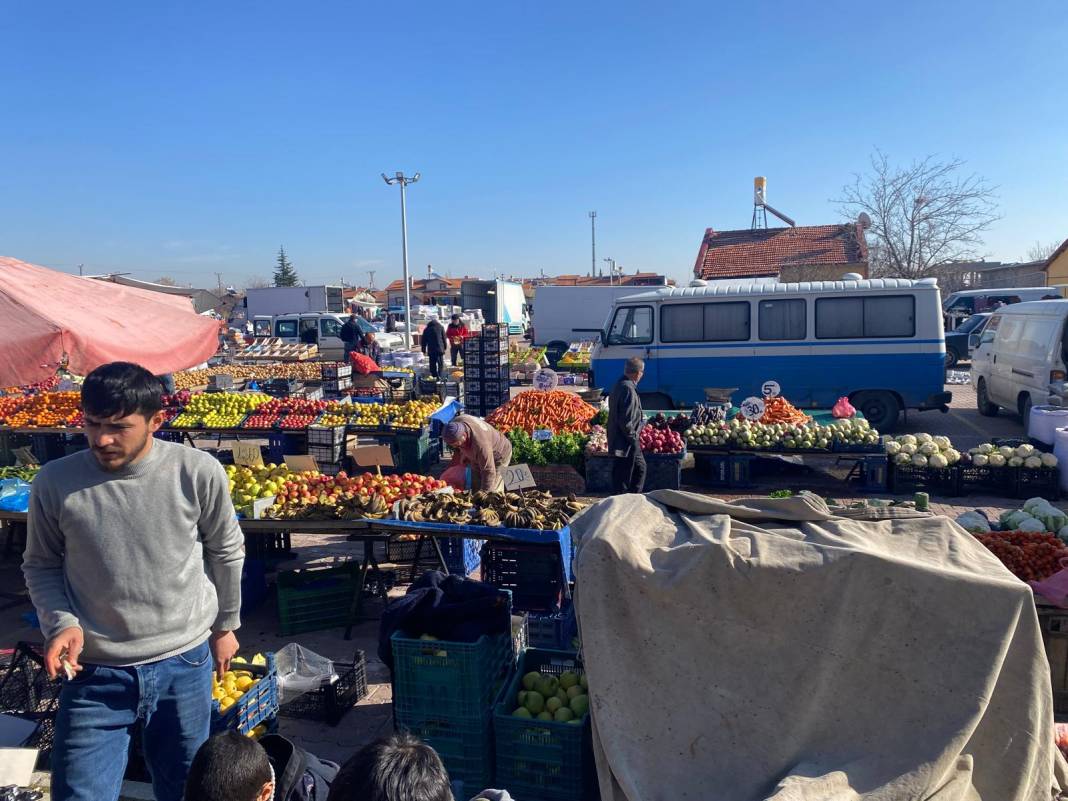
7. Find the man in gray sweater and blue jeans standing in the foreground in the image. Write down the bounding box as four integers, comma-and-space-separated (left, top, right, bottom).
22, 362, 245, 801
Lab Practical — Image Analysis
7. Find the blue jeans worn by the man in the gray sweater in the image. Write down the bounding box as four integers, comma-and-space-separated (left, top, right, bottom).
51, 642, 215, 801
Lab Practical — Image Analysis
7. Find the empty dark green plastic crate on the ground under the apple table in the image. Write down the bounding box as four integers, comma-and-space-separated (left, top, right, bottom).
278, 562, 359, 634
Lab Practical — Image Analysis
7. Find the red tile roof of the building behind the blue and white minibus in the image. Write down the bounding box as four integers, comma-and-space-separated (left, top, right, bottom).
693, 223, 867, 279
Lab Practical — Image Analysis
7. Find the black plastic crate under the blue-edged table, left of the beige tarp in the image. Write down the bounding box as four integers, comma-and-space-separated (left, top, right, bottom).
482, 541, 567, 612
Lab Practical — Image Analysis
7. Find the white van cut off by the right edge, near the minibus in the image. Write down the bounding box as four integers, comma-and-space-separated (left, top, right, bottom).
972, 300, 1068, 426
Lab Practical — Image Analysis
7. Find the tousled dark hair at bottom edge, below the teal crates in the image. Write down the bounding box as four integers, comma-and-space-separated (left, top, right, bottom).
327, 734, 453, 801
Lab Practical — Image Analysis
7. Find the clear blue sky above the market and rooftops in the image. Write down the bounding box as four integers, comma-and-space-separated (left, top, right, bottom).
0, 0, 1068, 286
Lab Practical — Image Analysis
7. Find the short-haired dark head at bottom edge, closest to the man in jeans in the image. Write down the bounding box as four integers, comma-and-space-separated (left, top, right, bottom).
185, 732, 274, 801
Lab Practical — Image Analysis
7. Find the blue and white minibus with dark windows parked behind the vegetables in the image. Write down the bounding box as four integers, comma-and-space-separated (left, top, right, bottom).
590, 279, 951, 430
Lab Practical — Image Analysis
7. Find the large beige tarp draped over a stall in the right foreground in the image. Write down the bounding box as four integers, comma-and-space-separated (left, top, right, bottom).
571, 490, 1066, 801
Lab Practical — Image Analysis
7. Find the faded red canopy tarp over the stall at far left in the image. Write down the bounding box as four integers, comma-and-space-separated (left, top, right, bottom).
0, 256, 219, 387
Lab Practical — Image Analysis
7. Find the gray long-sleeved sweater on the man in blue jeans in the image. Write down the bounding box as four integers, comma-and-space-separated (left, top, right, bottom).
22, 440, 245, 666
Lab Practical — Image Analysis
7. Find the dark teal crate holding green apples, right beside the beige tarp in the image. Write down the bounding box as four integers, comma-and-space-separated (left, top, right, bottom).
493, 648, 593, 801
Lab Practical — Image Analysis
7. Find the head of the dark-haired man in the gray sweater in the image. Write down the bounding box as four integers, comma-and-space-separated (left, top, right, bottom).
81, 362, 163, 470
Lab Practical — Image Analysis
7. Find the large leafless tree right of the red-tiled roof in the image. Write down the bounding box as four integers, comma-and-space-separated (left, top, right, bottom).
836, 150, 999, 279
